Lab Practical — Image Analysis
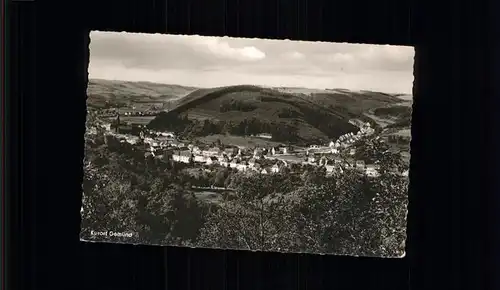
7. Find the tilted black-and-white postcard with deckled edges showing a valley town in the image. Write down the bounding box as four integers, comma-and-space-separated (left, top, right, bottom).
80, 31, 415, 258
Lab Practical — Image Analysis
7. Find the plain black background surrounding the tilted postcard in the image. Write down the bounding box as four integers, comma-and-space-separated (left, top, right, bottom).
6, 0, 498, 290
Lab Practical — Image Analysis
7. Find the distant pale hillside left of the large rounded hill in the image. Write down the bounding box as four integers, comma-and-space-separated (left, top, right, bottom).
87, 79, 197, 107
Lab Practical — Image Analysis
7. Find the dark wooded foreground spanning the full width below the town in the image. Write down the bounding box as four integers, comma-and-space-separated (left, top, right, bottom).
82, 131, 408, 256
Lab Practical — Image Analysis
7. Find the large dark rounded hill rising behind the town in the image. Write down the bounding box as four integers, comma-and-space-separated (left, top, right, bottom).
149, 85, 382, 143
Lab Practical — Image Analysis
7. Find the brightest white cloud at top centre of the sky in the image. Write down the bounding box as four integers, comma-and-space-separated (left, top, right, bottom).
191, 37, 266, 61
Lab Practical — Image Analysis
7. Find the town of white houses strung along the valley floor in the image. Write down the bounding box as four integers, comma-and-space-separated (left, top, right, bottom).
87, 111, 408, 181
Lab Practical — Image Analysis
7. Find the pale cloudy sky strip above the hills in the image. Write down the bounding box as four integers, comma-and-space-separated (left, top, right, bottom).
88, 31, 415, 94
